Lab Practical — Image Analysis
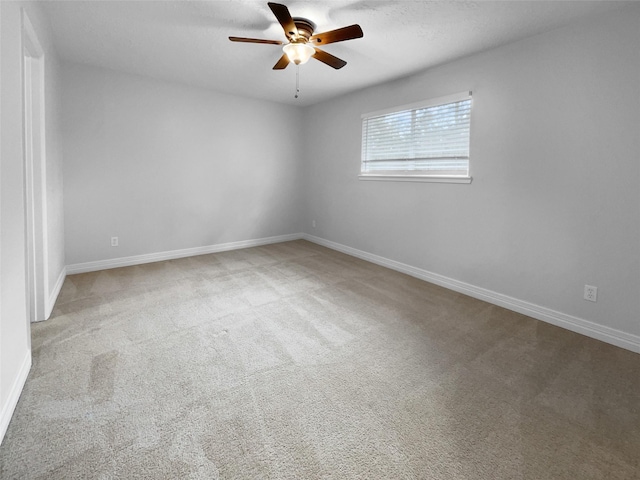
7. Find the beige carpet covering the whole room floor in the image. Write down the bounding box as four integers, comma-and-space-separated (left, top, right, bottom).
0, 241, 640, 480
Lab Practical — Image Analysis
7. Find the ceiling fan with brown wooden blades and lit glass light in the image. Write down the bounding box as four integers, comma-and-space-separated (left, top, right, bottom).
229, 2, 364, 70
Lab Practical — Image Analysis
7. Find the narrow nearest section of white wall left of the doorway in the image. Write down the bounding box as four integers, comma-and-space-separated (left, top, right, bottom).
0, 2, 30, 435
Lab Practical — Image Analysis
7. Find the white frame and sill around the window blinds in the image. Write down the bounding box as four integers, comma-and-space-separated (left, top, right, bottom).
358, 91, 472, 183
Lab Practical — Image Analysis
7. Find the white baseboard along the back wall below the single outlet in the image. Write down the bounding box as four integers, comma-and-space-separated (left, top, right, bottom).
66, 233, 302, 275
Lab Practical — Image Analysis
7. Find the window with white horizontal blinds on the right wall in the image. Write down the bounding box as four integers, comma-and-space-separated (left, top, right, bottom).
360, 92, 471, 183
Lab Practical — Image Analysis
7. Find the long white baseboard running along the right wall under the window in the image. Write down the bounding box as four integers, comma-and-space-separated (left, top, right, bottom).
302, 234, 640, 353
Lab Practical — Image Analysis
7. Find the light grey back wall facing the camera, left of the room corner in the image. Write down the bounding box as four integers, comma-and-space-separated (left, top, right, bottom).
62, 64, 301, 265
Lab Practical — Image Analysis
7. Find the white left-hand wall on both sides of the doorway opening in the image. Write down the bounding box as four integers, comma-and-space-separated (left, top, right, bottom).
0, 2, 65, 440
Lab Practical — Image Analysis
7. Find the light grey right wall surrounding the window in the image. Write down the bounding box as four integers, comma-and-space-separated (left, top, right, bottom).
304, 5, 640, 351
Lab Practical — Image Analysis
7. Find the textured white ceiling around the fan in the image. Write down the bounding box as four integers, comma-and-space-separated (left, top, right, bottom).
42, 0, 623, 106
